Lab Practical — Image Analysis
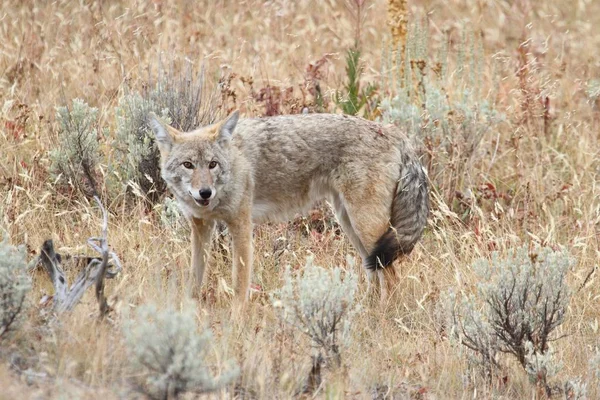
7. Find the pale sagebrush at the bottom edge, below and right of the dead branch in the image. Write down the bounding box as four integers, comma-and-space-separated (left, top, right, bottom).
124, 304, 239, 399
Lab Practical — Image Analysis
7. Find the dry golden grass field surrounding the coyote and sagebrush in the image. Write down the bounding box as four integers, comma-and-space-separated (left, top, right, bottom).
0, 0, 600, 399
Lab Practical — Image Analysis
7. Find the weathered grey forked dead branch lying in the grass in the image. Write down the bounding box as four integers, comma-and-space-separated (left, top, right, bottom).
39, 196, 122, 318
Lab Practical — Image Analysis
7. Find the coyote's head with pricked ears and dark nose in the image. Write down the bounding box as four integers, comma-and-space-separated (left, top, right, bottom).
148, 111, 239, 210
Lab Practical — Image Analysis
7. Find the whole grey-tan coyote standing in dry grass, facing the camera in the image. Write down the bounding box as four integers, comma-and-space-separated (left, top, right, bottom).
149, 110, 429, 303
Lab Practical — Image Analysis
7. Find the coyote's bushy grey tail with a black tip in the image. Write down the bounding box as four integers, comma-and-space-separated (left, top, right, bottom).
366, 160, 429, 270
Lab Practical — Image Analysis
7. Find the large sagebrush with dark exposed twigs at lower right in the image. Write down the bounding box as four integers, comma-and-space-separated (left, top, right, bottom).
447, 246, 573, 385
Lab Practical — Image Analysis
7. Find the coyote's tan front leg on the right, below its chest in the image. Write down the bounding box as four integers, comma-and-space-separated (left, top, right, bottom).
228, 210, 253, 303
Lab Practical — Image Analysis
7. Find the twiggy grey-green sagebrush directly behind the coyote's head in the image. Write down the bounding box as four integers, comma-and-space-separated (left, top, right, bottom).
110, 60, 218, 203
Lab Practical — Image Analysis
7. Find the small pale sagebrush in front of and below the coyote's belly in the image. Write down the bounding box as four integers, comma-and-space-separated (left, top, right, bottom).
271, 256, 358, 366
